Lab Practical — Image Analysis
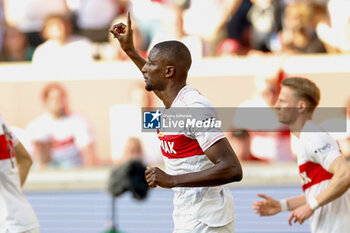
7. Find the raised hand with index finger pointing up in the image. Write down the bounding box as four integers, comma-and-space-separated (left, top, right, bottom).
109, 12, 134, 51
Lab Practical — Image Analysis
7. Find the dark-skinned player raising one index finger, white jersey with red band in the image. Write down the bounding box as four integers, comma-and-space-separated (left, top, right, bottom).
110, 14, 242, 233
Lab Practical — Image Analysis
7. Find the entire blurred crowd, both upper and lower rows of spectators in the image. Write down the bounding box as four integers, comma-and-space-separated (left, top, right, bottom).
0, 0, 350, 169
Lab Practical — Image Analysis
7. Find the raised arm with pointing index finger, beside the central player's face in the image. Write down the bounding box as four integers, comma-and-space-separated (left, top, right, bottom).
109, 12, 146, 71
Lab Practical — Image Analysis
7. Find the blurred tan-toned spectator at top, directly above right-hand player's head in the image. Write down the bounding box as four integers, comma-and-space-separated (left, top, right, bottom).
270, 2, 326, 54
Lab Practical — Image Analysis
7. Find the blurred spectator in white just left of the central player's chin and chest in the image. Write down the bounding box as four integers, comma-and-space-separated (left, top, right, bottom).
110, 82, 163, 165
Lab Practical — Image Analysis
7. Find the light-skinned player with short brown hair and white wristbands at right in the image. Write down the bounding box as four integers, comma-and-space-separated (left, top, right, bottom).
253, 78, 350, 233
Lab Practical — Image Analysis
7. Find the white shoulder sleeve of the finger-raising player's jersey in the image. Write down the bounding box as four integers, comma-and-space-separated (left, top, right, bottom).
191, 103, 225, 151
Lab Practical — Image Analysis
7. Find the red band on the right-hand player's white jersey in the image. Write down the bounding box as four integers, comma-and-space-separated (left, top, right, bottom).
299, 161, 333, 191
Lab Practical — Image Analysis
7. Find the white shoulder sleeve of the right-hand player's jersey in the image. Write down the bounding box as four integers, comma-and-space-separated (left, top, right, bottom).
304, 132, 341, 170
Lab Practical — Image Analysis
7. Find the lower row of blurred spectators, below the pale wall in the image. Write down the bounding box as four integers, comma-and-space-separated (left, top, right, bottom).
7, 76, 350, 170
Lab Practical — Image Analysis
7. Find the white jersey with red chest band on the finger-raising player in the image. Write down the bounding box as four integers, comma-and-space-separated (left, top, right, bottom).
158, 85, 235, 230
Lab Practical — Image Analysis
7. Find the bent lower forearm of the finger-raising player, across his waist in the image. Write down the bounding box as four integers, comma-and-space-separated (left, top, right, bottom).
172, 161, 242, 187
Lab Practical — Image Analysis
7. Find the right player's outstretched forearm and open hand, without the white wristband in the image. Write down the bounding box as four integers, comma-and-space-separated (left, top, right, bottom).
253, 193, 306, 216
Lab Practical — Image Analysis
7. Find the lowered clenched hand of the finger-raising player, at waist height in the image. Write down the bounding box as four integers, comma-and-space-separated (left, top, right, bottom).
145, 167, 173, 188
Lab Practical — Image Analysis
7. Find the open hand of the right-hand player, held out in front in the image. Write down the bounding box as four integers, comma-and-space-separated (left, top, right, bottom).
253, 193, 281, 216
